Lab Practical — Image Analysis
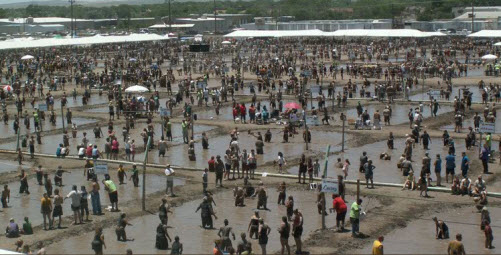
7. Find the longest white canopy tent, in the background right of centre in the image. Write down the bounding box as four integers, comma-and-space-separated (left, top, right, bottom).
225, 29, 446, 38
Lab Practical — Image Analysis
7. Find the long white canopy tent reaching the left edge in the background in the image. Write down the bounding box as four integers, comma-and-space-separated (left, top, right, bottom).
0, 34, 170, 50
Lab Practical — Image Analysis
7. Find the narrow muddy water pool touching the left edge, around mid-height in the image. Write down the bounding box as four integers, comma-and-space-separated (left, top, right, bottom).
0, 117, 97, 138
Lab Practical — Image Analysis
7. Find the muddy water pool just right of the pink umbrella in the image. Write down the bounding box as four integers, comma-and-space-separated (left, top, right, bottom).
345, 104, 454, 128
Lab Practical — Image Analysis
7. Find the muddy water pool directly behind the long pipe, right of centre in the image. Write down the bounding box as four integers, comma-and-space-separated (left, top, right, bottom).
288, 139, 465, 185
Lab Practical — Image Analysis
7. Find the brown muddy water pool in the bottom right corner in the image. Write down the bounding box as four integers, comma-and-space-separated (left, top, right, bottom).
350, 207, 501, 254
